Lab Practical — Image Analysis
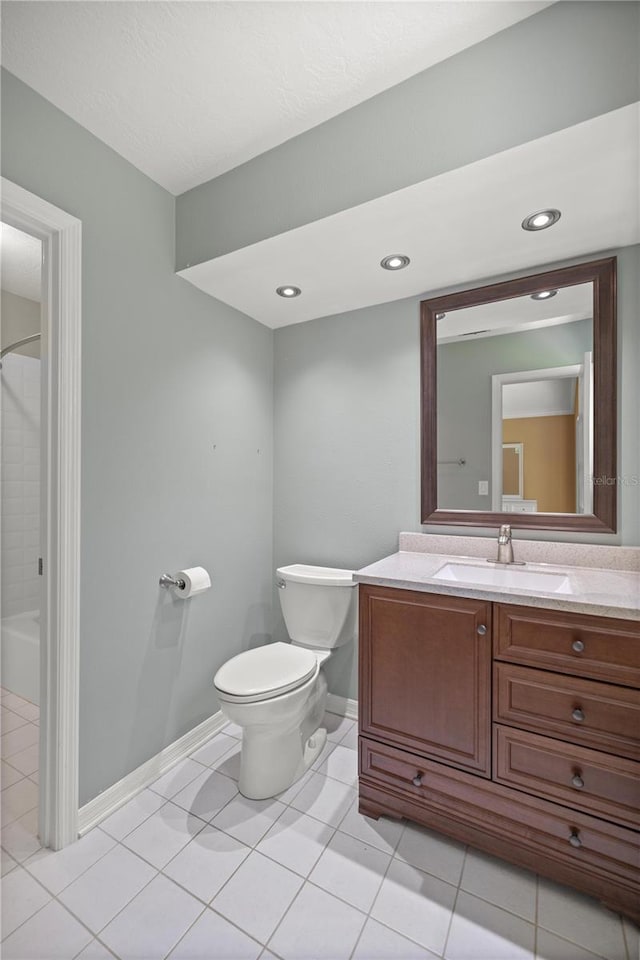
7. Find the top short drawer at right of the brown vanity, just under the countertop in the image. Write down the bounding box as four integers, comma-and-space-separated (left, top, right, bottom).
494, 603, 640, 687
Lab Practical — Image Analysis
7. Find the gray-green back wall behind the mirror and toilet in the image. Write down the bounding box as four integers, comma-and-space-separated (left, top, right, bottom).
274, 246, 640, 698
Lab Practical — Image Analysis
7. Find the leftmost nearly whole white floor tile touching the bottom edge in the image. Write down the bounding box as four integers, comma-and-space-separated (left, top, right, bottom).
100, 876, 203, 960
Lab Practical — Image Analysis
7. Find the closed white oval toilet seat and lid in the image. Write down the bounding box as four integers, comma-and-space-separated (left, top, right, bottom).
213, 642, 320, 703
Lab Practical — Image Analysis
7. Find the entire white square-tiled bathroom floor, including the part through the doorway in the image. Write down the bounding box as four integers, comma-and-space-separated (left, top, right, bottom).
2, 694, 639, 960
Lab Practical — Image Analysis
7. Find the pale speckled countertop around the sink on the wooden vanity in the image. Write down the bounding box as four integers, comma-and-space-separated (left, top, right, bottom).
354, 550, 640, 620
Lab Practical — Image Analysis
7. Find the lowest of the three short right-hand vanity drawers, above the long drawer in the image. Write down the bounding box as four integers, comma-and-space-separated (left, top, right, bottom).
493, 724, 640, 830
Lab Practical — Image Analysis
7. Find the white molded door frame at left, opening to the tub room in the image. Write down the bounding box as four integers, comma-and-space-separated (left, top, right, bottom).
1, 177, 82, 850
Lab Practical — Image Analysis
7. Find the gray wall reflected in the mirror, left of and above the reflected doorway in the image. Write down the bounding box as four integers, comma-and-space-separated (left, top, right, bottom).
437, 320, 593, 510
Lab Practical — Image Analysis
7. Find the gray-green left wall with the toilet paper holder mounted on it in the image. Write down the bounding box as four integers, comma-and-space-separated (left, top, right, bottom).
2, 72, 273, 803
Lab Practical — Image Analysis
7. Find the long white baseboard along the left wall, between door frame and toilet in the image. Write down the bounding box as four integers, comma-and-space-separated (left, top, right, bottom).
78, 710, 227, 836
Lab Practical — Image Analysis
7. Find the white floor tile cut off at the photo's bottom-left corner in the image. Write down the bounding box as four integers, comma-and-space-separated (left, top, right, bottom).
2, 900, 93, 960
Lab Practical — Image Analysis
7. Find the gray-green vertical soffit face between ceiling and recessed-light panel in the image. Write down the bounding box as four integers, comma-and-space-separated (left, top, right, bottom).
176, 0, 640, 269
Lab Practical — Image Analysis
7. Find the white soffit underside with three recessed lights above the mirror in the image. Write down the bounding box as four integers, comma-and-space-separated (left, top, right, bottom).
180, 104, 640, 329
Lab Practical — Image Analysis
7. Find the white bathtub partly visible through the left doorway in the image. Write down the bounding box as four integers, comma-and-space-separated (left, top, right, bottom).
0, 610, 40, 704
